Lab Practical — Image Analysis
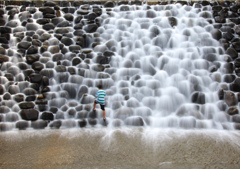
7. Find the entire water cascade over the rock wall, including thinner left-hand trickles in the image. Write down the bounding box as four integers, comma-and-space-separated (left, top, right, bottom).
0, 0, 238, 130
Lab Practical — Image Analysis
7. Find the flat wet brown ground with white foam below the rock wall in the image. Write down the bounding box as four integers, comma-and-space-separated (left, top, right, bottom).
0, 128, 240, 169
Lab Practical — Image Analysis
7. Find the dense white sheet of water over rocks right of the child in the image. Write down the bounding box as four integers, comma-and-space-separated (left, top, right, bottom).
89, 4, 231, 129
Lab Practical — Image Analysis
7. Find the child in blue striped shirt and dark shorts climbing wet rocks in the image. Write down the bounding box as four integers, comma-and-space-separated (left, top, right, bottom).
93, 85, 106, 121
